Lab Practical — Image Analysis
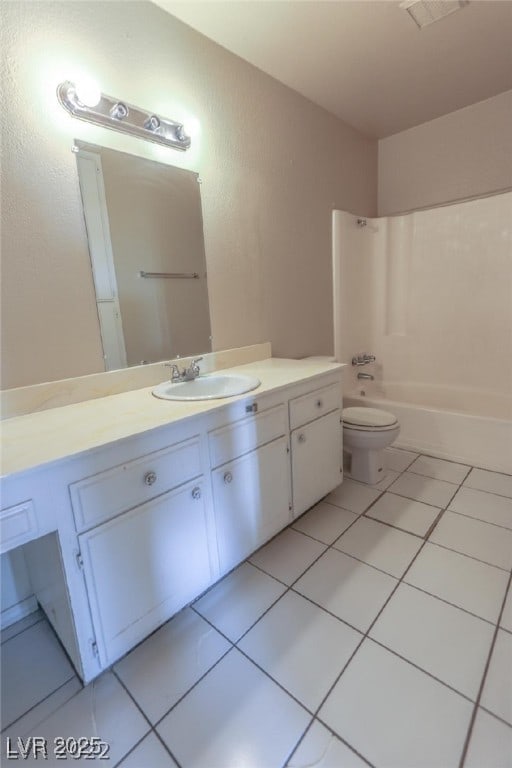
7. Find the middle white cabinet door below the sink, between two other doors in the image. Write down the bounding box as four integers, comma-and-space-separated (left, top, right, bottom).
212, 437, 291, 573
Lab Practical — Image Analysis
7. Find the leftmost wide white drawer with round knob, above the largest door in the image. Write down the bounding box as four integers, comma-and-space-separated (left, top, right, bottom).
70, 437, 202, 531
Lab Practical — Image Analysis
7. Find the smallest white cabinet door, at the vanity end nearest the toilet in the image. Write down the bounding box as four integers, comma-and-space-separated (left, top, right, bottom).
291, 410, 343, 517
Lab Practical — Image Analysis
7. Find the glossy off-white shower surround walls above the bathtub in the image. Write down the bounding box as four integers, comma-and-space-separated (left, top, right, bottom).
333, 192, 512, 398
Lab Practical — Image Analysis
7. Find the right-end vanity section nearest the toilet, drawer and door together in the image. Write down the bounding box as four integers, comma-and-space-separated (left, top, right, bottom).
290, 384, 343, 517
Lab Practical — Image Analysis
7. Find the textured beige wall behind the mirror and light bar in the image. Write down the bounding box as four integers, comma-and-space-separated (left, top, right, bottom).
0, 1, 377, 387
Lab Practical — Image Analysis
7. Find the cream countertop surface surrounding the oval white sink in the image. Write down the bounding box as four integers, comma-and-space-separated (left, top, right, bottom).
0, 358, 343, 476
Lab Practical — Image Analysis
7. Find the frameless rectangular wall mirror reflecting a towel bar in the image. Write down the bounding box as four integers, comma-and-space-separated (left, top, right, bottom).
74, 140, 211, 370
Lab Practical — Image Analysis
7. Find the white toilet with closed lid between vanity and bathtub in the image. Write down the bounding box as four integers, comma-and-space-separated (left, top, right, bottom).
342, 408, 400, 485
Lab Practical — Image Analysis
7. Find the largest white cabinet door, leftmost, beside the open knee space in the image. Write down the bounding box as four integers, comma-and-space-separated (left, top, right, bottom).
78, 481, 213, 666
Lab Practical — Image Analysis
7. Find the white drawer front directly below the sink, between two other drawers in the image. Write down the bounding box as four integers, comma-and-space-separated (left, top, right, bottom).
209, 405, 288, 468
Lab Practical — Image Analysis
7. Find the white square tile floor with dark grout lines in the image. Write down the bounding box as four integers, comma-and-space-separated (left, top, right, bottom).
2, 449, 512, 768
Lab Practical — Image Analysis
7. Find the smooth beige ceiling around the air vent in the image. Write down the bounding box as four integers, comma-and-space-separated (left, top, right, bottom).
155, 0, 512, 138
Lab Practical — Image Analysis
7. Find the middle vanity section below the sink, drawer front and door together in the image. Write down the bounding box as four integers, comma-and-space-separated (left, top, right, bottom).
209, 402, 292, 573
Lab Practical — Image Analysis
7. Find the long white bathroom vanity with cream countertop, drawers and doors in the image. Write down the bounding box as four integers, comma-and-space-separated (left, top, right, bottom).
0, 358, 342, 682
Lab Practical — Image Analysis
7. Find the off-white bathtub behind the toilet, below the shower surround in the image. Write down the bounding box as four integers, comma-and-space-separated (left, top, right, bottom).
343, 381, 512, 474
